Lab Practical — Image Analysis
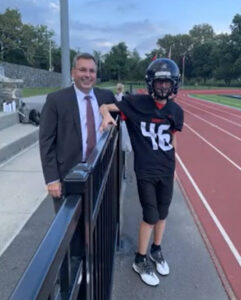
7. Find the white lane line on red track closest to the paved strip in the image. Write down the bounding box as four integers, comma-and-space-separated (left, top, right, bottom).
176, 153, 241, 267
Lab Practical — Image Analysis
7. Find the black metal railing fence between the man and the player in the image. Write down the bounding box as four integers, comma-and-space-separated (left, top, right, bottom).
10, 122, 123, 300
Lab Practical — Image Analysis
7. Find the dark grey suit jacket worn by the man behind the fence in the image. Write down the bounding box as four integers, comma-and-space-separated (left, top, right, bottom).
39, 86, 115, 183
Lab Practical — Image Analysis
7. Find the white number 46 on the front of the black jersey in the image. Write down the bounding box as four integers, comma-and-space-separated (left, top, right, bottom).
141, 122, 173, 151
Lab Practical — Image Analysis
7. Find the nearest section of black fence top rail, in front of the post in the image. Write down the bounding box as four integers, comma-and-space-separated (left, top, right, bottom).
10, 196, 82, 300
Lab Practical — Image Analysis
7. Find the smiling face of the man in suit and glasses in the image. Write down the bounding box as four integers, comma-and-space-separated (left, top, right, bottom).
72, 58, 97, 94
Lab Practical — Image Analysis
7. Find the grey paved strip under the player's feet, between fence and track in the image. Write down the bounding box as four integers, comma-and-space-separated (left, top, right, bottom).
112, 154, 228, 300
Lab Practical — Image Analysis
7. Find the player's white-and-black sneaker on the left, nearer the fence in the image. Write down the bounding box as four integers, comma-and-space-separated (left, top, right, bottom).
132, 258, 160, 286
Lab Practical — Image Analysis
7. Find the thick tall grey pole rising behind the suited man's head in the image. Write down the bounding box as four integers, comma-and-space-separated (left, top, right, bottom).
60, 0, 71, 87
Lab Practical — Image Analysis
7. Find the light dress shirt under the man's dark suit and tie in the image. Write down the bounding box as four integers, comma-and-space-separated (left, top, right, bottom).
74, 85, 102, 161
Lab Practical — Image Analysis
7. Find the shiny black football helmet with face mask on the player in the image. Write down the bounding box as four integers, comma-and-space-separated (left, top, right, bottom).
145, 58, 180, 100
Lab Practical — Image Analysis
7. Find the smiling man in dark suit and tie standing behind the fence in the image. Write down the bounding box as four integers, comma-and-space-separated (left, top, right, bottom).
39, 53, 115, 211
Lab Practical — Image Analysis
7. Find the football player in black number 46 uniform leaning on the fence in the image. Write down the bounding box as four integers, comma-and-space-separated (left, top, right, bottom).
100, 58, 183, 286
